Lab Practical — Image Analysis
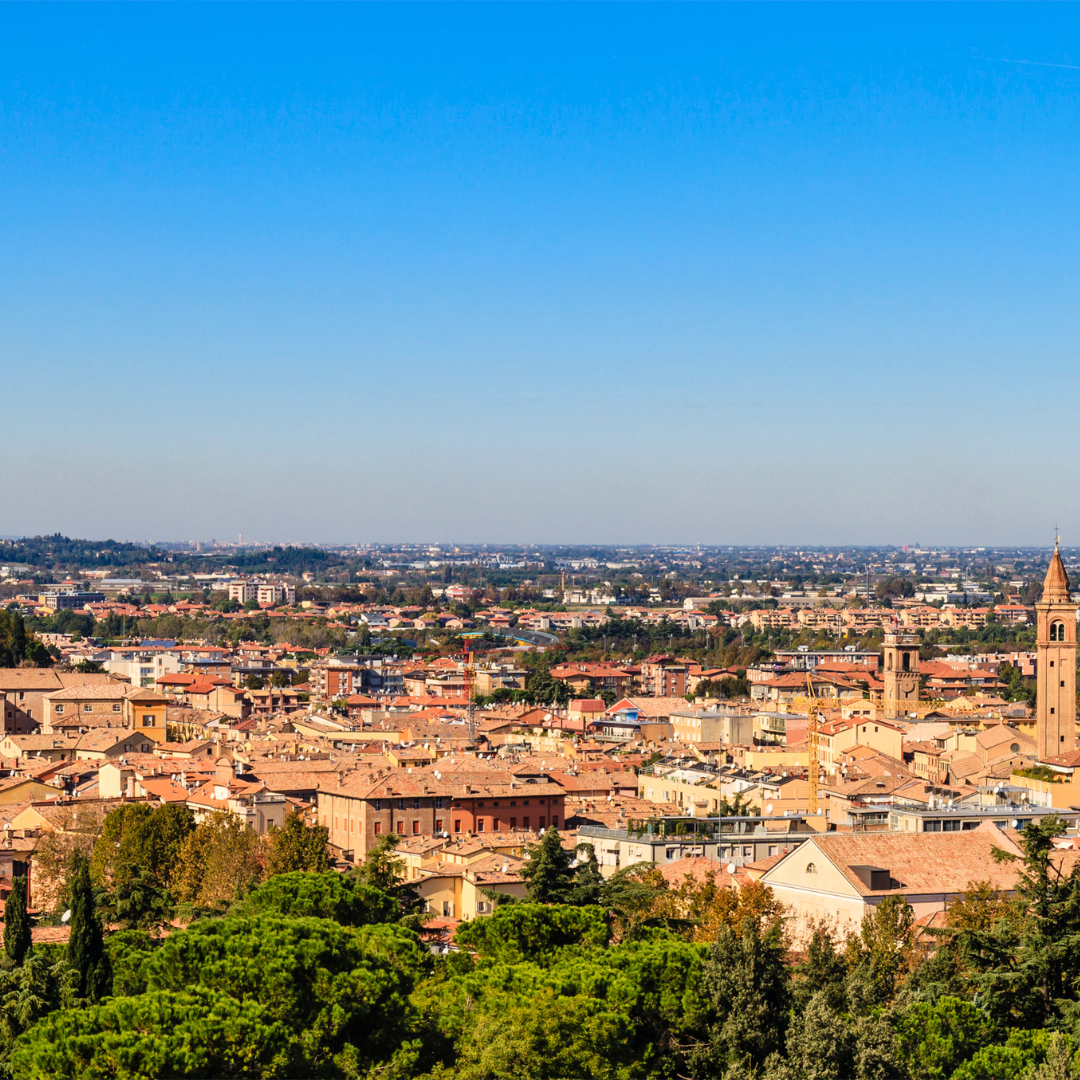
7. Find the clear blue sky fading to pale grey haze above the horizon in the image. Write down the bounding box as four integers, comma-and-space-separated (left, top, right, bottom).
0, 3, 1080, 544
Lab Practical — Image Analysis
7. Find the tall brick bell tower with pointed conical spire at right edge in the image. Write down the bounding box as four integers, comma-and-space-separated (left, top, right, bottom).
1035, 544, 1077, 761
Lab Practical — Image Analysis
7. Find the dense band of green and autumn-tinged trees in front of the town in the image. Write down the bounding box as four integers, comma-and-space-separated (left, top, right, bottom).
6, 811, 1080, 1080
